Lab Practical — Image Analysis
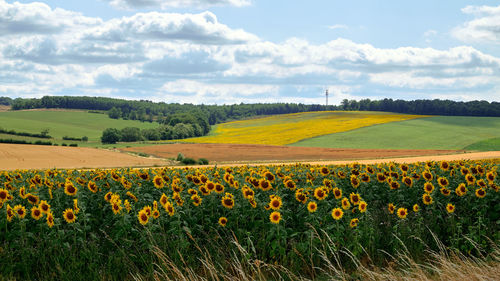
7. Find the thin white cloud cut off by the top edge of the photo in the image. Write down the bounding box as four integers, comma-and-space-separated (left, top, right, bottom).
106, 0, 251, 9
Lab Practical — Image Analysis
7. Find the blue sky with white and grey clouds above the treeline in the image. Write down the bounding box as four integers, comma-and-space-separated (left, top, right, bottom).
0, 0, 500, 104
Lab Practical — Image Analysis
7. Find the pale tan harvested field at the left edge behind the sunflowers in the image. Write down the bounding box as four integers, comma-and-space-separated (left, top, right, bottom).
0, 143, 167, 170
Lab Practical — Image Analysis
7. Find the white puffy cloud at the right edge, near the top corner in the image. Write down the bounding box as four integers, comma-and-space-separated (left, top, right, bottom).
452, 6, 500, 44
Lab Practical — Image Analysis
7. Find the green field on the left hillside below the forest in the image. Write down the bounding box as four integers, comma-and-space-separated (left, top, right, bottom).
0, 111, 158, 146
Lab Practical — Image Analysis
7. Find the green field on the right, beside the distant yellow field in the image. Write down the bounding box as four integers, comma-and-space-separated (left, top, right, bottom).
291, 116, 500, 150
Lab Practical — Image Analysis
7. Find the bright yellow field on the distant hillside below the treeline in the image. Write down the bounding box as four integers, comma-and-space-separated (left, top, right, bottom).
183, 111, 425, 145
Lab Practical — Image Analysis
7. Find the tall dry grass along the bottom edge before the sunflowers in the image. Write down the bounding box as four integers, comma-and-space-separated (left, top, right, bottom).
132, 226, 500, 281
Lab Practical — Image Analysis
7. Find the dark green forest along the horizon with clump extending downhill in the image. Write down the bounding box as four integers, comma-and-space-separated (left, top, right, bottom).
0, 96, 500, 142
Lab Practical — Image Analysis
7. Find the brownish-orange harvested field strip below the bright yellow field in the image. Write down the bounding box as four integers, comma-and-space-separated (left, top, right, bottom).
122, 143, 457, 163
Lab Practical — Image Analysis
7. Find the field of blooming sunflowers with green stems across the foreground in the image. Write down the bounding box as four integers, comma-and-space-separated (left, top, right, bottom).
0, 160, 500, 280
